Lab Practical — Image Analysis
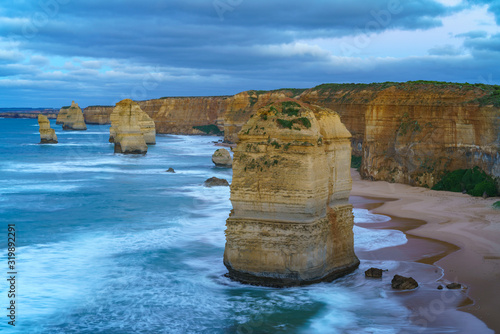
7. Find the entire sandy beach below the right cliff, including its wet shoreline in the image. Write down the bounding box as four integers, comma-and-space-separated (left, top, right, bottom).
351, 170, 500, 333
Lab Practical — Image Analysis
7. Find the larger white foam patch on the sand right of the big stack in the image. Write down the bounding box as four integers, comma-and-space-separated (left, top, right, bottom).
353, 225, 408, 251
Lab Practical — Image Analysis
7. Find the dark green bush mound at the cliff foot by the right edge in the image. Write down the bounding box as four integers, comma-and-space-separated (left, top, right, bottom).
432, 166, 498, 197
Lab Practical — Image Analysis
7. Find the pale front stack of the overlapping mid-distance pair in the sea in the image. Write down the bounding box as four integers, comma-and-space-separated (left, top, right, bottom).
110, 99, 148, 154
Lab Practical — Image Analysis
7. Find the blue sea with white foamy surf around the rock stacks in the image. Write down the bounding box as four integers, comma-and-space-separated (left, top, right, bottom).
0, 119, 454, 334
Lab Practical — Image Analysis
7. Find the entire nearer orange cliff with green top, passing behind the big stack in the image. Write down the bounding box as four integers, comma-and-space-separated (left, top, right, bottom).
224, 82, 500, 187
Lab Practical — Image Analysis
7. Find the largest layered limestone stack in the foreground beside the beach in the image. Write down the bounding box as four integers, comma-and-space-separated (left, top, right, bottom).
224, 99, 359, 287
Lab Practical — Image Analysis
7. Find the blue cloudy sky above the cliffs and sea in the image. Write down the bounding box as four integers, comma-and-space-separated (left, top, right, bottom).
0, 0, 500, 108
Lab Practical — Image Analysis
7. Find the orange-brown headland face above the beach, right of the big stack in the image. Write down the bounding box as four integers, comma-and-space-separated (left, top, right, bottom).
360, 86, 500, 187
